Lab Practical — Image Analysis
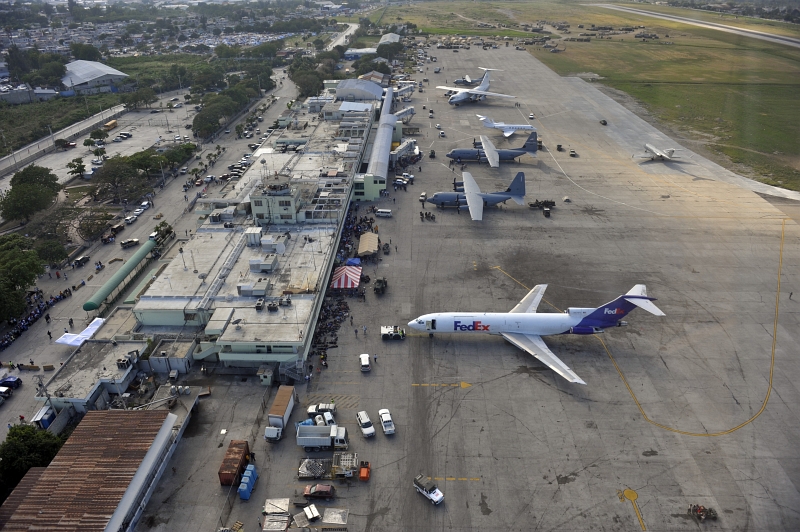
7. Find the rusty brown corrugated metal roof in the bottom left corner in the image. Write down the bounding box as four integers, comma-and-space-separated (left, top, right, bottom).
0, 410, 169, 532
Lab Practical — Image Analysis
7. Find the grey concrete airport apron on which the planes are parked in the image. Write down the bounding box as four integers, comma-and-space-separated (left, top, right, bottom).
290, 47, 800, 531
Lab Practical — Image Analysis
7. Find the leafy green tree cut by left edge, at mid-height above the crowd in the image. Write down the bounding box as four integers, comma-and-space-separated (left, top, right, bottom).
0, 233, 44, 320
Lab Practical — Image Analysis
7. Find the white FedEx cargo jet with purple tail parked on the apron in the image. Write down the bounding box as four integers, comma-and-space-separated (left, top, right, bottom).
408, 284, 665, 384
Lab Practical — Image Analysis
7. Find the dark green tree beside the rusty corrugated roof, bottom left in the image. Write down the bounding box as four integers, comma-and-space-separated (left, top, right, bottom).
0, 425, 64, 500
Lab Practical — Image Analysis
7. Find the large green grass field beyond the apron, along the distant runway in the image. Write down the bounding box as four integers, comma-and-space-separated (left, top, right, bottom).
375, 0, 800, 190
